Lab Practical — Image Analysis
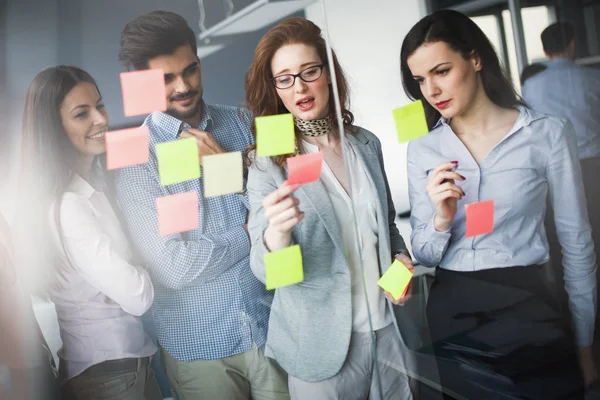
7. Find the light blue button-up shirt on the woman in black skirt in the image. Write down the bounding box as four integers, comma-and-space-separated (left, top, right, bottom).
408, 107, 596, 346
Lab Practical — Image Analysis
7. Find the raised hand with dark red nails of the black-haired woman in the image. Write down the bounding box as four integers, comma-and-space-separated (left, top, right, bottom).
427, 161, 466, 232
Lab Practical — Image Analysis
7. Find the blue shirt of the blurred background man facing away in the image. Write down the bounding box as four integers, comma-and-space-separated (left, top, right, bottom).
523, 58, 600, 159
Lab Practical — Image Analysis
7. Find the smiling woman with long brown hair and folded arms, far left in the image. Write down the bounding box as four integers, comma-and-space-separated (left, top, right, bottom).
15, 66, 162, 400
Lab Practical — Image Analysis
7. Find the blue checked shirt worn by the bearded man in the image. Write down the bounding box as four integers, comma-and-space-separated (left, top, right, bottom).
116, 104, 273, 362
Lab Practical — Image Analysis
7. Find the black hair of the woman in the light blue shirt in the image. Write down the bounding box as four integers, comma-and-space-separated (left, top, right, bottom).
400, 10, 523, 129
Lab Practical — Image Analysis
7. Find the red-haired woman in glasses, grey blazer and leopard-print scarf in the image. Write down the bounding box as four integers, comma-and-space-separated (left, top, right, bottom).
246, 18, 412, 399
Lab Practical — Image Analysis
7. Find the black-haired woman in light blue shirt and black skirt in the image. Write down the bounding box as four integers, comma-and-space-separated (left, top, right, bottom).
401, 10, 596, 399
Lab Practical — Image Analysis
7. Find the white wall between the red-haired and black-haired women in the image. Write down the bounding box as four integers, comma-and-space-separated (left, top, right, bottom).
306, 0, 425, 219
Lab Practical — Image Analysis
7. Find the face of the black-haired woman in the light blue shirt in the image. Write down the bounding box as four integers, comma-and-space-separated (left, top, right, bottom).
407, 42, 482, 119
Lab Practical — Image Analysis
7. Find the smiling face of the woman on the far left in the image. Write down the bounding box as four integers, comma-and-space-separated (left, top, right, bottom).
59, 82, 108, 156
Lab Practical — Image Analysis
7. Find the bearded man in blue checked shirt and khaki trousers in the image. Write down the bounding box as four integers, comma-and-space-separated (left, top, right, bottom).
115, 11, 289, 400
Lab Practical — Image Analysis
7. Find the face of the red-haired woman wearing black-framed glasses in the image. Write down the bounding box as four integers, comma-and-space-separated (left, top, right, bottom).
271, 43, 331, 121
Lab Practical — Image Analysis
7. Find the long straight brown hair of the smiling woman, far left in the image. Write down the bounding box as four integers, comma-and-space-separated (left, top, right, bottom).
13, 65, 100, 296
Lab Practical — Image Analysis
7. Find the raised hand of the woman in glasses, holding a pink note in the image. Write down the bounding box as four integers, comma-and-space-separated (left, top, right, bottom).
263, 182, 304, 251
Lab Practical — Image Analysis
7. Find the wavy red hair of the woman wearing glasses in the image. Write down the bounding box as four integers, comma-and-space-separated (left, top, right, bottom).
246, 17, 354, 168
